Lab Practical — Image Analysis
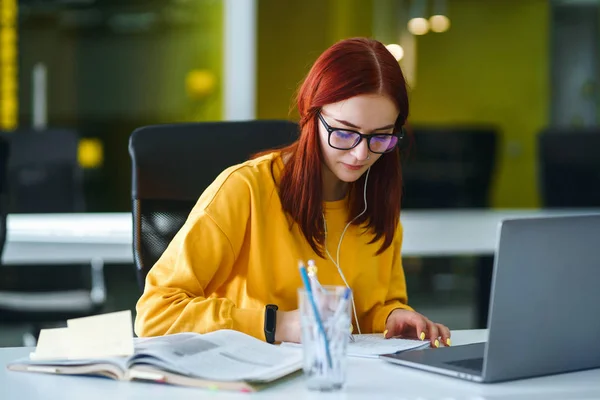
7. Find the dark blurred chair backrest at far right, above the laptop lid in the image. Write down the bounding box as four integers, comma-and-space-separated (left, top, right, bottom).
538, 128, 600, 207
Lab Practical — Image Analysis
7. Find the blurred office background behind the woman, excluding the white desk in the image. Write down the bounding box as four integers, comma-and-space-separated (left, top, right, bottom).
0, 0, 600, 346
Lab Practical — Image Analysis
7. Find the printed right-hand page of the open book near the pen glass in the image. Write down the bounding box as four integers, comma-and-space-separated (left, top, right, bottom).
130, 330, 302, 381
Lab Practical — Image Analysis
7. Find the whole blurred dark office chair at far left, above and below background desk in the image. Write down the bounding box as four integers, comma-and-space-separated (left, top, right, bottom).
0, 129, 106, 344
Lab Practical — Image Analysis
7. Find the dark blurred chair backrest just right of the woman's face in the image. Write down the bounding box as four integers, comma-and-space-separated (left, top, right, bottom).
402, 126, 499, 208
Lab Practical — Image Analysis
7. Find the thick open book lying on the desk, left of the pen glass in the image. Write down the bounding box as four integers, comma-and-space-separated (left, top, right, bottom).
8, 330, 302, 391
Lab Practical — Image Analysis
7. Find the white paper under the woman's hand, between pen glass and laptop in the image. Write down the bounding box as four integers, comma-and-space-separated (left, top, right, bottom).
282, 333, 430, 358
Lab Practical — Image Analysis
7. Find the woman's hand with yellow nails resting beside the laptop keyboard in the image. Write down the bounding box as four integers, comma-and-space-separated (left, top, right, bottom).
384, 309, 450, 347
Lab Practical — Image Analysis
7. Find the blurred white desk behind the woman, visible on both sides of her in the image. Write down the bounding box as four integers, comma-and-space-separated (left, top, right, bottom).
3, 209, 600, 264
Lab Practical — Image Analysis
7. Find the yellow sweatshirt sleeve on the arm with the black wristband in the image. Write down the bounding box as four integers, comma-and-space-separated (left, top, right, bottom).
135, 169, 265, 340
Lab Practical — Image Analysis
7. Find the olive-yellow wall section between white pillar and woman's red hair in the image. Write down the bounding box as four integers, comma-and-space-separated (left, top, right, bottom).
256, 0, 373, 119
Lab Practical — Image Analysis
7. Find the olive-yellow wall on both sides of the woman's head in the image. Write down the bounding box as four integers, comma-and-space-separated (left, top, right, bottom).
257, 0, 549, 207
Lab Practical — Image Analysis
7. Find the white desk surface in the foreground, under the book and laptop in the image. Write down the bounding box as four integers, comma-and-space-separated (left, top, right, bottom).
0, 330, 600, 400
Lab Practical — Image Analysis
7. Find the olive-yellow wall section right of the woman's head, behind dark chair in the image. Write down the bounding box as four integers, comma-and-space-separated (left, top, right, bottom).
411, 0, 550, 207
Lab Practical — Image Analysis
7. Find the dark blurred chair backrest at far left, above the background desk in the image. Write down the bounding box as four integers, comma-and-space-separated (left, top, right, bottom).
2, 129, 85, 213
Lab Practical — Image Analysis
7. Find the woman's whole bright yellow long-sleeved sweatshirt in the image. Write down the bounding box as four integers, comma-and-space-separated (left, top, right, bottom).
135, 153, 410, 340
